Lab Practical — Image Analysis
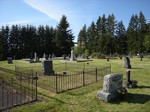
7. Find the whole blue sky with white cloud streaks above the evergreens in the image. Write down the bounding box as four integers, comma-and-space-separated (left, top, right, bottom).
0, 0, 150, 41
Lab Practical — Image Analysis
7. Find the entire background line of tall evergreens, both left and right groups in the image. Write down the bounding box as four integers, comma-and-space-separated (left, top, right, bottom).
0, 12, 150, 60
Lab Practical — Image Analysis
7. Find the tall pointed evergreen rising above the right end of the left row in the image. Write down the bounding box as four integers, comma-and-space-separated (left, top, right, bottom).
55, 15, 74, 56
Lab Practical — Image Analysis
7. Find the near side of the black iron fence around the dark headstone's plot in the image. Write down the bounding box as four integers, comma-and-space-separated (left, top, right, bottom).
38, 66, 111, 93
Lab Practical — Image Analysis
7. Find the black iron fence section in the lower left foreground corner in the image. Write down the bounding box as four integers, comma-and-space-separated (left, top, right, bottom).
0, 74, 37, 111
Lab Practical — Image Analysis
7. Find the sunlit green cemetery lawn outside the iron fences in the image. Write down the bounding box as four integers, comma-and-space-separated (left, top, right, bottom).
0, 58, 150, 112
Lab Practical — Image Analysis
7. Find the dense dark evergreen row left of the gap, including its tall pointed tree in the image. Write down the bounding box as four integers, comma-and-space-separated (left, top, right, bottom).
0, 15, 74, 60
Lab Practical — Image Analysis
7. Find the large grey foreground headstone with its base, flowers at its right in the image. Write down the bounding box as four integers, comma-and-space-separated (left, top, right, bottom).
97, 74, 123, 102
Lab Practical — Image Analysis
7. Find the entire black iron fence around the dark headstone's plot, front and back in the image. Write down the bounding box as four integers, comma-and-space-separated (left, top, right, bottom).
12, 63, 111, 93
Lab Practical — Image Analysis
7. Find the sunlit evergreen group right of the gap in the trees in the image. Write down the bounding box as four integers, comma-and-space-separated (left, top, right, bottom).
75, 12, 150, 56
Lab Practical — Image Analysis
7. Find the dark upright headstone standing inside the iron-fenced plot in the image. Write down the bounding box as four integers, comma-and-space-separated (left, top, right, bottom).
42, 60, 54, 75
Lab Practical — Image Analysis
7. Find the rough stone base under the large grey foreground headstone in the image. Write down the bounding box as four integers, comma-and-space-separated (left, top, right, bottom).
97, 90, 119, 102
